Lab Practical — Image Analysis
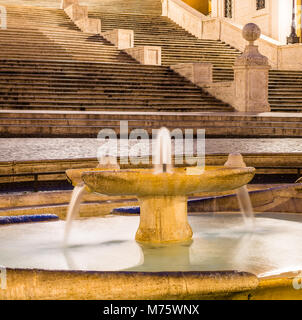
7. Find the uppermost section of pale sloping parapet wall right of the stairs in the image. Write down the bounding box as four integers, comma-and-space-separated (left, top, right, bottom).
162, 0, 205, 39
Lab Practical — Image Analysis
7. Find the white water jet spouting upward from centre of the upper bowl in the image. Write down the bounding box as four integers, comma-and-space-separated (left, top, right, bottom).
153, 128, 172, 173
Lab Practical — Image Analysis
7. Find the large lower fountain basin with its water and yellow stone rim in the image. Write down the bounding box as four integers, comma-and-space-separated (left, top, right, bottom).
0, 213, 302, 299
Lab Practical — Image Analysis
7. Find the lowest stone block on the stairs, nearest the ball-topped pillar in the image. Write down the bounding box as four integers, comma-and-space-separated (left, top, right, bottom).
171, 62, 213, 86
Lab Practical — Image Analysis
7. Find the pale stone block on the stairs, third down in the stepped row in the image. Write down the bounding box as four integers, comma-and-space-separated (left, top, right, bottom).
102, 29, 134, 50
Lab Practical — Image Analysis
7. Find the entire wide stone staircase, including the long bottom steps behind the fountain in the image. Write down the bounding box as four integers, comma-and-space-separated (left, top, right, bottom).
0, 0, 302, 137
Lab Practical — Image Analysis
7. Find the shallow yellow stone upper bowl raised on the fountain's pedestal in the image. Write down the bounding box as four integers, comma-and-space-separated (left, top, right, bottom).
66, 167, 255, 196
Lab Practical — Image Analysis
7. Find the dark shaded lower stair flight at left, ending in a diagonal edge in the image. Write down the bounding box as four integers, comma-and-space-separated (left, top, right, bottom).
0, 60, 232, 111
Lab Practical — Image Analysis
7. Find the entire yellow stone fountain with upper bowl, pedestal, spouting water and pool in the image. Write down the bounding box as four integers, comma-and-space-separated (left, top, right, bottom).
0, 129, 302, 299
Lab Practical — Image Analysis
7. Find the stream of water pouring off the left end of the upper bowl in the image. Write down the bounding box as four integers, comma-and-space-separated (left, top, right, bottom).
63, 185, 85, 247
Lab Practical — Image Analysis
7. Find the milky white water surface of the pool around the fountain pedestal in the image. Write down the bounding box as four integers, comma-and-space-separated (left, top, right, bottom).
0, 214, 302, 277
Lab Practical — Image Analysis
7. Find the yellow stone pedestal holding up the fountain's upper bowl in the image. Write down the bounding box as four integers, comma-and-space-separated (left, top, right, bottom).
135, 196, 193, 243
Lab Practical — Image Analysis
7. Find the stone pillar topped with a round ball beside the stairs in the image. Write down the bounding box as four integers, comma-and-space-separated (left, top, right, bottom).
233, 23, 270, 112
